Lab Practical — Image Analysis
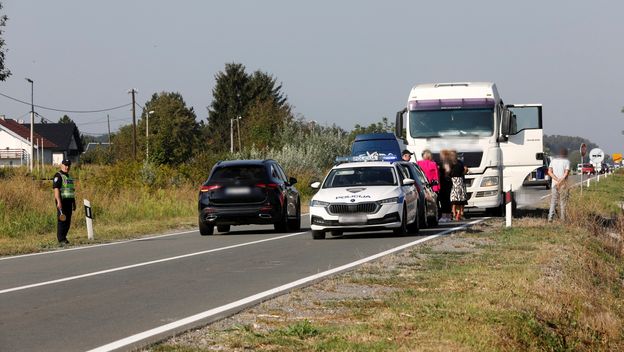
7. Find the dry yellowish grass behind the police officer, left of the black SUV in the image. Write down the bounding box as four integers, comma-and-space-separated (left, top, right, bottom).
0, 166, 197, 255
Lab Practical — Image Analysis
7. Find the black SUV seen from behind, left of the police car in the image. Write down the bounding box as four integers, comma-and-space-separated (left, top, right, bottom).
198, 159, 301, 236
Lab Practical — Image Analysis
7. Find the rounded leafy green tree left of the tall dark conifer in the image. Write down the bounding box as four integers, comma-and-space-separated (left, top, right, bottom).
138, 92, 200, 164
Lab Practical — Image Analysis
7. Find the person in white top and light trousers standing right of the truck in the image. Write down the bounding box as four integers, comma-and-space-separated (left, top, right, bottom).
548, 148, 570, 222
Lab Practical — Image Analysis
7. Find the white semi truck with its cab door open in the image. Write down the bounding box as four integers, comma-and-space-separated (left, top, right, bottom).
395, 82, 544, 215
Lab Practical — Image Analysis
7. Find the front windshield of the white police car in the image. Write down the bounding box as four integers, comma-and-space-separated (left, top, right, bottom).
323, 166, 397, 188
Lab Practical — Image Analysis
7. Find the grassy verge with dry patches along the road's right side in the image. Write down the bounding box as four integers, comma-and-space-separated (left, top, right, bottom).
150, 175, 624, 352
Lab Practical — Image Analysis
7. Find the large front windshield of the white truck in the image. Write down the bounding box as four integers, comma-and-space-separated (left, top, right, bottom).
409, 108, 494, 138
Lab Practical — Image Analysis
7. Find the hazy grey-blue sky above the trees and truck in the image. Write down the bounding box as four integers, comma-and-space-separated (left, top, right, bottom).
0, 0, 624, 154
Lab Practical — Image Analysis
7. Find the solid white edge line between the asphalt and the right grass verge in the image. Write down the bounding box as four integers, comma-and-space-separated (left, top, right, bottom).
89, 218, 489, 352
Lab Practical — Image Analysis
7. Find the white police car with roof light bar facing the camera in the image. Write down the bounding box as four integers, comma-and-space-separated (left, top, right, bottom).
310, 156, 419, 239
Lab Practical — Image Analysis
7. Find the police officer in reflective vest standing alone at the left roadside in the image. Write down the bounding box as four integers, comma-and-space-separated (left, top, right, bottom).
52, 159, 76, 245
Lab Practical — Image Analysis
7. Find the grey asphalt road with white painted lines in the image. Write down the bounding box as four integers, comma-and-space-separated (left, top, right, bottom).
0, 179, 584, 351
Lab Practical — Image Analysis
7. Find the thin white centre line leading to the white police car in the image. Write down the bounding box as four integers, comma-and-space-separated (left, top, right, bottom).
0, 232, 306, 294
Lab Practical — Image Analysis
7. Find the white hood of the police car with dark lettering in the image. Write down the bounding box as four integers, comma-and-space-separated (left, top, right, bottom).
314, 186, 402, 204
